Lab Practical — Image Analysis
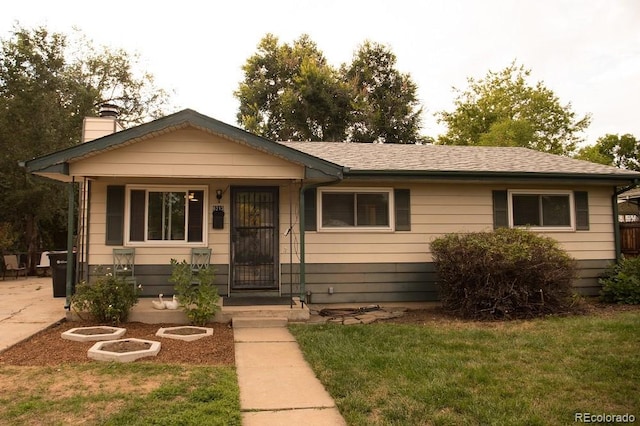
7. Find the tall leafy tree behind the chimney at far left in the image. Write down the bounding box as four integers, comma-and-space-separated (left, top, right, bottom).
0, 26, 168, 266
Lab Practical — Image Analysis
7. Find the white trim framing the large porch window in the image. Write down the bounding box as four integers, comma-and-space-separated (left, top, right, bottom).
124, 185, 210, 247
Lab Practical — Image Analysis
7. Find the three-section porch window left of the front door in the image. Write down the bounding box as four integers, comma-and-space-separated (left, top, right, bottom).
127, 186, 207, 244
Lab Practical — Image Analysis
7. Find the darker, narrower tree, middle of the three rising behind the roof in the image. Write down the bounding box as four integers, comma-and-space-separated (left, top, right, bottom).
343, 41, 422, 143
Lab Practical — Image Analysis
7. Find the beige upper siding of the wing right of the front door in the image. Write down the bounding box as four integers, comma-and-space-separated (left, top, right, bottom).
306, 182, 615, 263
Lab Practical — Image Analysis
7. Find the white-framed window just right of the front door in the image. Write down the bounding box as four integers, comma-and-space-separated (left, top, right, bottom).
318, 188, 394, 230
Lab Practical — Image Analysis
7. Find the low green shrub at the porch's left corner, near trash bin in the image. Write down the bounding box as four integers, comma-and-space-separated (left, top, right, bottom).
71, 273, 139, 325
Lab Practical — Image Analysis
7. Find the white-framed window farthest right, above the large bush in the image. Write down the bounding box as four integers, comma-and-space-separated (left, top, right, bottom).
508, 190, 575, 230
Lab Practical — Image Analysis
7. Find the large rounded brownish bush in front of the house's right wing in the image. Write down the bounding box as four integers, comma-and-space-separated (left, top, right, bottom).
431, 228, 576, 319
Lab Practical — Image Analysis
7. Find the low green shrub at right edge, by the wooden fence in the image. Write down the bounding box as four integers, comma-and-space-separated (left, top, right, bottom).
600, 257, 640, 305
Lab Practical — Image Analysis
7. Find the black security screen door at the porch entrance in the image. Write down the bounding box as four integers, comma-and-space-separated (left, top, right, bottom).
231, 187, 278, 290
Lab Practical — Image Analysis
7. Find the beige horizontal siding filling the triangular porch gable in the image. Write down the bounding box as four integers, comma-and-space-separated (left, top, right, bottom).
70, 129, 304, 179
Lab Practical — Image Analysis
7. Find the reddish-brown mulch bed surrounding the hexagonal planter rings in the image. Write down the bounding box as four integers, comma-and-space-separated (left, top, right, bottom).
0, 321, 235, 366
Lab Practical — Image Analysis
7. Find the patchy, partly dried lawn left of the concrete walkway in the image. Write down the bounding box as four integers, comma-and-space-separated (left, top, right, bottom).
0, 363, 241, 425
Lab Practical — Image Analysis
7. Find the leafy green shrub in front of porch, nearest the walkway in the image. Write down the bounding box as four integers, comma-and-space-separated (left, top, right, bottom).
169, 259, 220, 326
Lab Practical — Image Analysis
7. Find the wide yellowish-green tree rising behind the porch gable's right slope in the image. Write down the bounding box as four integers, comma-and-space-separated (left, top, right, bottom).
234, 34, 348, 140
